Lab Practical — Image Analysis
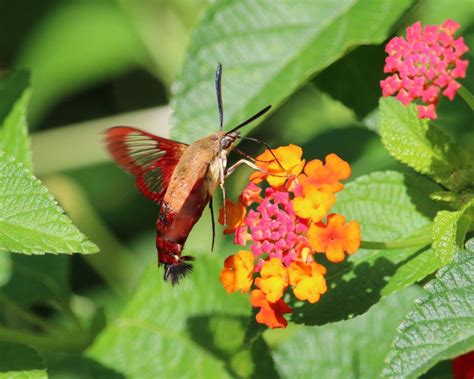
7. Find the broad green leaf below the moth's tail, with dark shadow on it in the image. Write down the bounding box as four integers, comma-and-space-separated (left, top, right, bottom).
87, 257, 271, 378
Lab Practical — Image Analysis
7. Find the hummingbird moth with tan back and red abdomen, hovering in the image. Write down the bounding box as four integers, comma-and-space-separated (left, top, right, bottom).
105, 64, 271, 285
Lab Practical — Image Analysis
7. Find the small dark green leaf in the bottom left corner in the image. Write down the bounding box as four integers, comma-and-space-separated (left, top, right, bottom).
0, 342, 48, 379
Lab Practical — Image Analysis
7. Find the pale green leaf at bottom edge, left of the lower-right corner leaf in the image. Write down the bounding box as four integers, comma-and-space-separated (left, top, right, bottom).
265, 288, 421, 379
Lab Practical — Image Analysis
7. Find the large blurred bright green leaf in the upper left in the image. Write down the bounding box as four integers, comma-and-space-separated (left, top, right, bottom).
17, 1, 146, 121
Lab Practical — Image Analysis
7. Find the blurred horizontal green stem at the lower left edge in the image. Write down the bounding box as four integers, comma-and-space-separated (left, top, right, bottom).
0, 326, 91, 352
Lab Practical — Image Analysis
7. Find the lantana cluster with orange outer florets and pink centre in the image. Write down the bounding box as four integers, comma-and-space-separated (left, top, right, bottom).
219, 145, 360, 328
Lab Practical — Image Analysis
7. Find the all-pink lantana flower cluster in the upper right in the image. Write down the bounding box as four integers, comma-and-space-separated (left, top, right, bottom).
380, 20, 468, 119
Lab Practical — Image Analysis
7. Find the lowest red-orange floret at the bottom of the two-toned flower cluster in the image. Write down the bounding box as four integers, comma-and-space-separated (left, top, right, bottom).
250, 290, 292, 329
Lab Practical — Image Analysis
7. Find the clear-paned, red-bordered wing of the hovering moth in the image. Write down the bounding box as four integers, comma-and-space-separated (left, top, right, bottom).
105, 126, 189, 203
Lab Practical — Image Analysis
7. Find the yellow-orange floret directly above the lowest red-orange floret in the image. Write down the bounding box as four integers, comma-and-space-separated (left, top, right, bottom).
255, 258, 288, 303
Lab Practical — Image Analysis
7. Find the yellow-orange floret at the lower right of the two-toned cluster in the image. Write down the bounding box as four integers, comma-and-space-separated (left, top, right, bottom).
288, 262, 327, 303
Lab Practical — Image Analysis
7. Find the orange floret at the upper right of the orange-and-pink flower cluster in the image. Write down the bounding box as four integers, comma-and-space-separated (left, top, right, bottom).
298, 154, 351, 192
